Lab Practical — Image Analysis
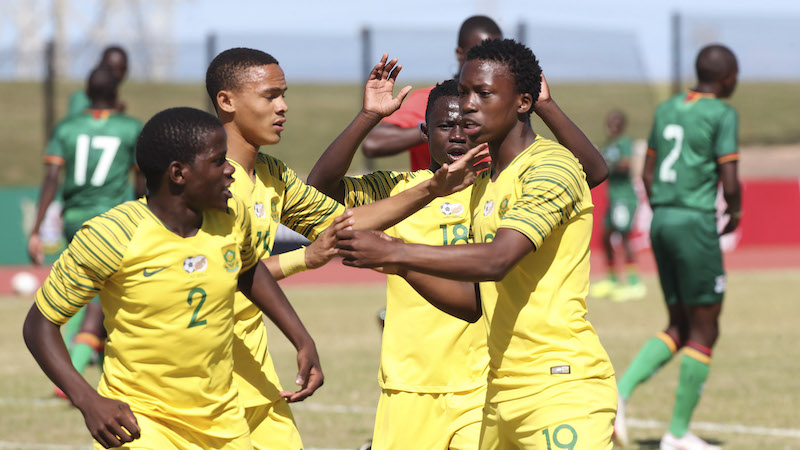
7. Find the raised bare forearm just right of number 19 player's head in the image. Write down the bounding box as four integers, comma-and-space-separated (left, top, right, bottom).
535, 99, 608, 188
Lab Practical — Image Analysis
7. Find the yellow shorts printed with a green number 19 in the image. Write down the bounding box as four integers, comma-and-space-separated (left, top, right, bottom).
480, 377, 617, 450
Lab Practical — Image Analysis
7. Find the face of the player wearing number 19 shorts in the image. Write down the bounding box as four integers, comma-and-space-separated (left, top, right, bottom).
458, 59, 523, 144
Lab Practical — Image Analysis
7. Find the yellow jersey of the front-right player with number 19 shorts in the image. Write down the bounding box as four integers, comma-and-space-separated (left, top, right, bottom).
470, 137, 614, 402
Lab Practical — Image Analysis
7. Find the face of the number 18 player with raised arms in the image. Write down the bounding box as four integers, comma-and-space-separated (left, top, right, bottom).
426, 97, 470, 166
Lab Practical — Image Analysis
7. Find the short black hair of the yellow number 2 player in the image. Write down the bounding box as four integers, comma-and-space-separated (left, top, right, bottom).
136, 107, 222, 192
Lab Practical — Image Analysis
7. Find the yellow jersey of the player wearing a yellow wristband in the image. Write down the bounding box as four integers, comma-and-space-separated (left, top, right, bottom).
228, 153, 344, 407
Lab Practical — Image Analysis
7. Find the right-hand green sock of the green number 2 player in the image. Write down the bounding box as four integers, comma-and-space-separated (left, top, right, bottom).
669, 341, 711, 437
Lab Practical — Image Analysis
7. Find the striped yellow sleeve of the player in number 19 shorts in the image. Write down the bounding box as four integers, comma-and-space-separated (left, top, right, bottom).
499, 151, 586, 249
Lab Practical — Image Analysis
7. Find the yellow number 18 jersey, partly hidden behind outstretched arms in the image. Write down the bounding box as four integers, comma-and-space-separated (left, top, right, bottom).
344, 170, 489, 393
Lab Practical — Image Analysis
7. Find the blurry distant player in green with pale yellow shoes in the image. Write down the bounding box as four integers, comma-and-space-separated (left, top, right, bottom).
589, 110, 646, 301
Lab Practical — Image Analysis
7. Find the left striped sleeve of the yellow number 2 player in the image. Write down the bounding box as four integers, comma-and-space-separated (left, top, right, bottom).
35, 219, 122, 325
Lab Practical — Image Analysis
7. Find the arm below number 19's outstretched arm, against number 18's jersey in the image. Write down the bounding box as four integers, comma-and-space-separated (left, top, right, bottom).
402, 271, 481, 322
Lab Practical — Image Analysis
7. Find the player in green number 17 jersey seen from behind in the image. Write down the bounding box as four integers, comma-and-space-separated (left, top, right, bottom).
28, 66, 145, 396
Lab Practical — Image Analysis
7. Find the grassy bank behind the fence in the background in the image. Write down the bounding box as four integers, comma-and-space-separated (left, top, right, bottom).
0, 82, 800, 186
